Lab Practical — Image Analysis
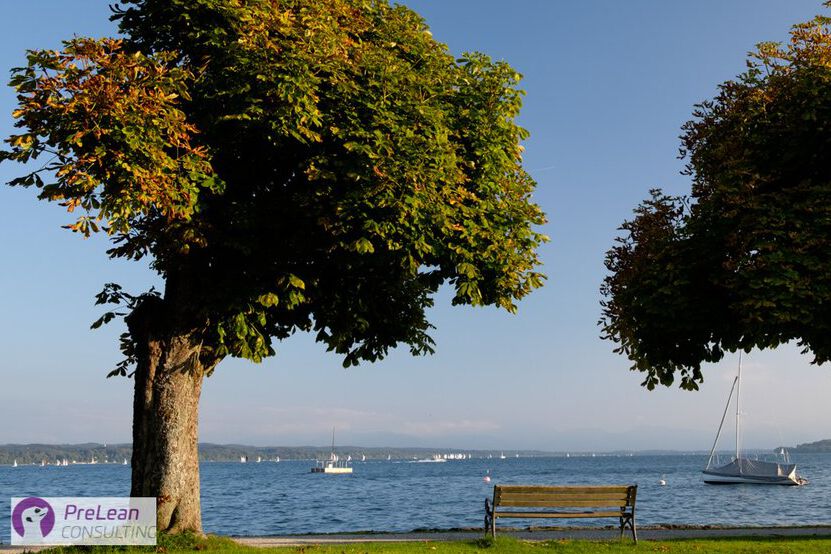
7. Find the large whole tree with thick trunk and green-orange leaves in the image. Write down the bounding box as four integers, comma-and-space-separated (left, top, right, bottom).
0, 0, 546, 532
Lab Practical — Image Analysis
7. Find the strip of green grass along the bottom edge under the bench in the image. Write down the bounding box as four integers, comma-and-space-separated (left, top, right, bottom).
37, 535, 831, 554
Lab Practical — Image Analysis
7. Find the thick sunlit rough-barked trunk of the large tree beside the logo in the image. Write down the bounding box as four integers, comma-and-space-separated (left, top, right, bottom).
127, 298, 215, 534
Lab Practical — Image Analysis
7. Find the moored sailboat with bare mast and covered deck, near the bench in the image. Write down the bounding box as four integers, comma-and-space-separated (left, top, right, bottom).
703, 353, 808, 486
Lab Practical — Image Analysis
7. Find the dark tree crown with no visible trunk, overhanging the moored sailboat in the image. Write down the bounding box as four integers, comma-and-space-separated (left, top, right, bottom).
600, 11, 831, 389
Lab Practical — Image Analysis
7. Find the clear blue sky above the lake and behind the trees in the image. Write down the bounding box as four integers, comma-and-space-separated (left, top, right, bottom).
0, 0, 831, 451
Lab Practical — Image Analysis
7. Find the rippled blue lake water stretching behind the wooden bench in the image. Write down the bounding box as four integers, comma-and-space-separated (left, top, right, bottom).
0, 454, 831, 544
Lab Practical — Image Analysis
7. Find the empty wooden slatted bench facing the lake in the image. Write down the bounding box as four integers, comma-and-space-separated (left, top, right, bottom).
485, 485, 638, 543
